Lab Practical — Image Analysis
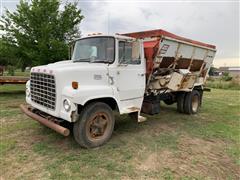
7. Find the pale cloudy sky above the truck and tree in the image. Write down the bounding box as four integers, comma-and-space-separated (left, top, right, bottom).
0, 0, 240, 67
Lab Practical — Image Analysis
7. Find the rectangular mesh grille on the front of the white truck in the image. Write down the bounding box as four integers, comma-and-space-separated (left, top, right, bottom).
30, 73, 56, 110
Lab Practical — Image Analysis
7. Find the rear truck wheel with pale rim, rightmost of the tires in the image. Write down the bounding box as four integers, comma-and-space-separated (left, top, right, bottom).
184, 90, 201, 114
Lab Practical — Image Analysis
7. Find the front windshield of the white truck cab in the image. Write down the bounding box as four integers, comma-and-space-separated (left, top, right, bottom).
72, 37, 115, 63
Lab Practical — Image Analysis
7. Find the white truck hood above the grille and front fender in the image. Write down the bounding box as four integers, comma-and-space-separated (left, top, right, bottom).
31, 60, 108, 87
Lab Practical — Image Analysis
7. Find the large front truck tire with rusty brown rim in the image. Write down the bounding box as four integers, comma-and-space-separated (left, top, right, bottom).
73, 102, 115, 148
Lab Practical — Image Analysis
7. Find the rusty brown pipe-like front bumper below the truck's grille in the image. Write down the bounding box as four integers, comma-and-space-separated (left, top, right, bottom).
20, 104, 70, 136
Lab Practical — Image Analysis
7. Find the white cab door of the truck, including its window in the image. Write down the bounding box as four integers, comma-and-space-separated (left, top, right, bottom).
115, 40, 146, 101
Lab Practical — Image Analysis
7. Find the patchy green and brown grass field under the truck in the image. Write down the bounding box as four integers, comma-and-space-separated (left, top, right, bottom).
0, 85, 240, 180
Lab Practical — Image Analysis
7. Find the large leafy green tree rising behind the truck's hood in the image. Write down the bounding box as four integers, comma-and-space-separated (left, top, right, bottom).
0, 0, 84, 68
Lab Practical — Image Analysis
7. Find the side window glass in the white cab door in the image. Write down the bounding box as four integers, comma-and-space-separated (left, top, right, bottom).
118, 41, 141, 64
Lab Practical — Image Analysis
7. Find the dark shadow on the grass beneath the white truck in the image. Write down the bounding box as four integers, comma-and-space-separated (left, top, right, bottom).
37, 106, 191, 151
